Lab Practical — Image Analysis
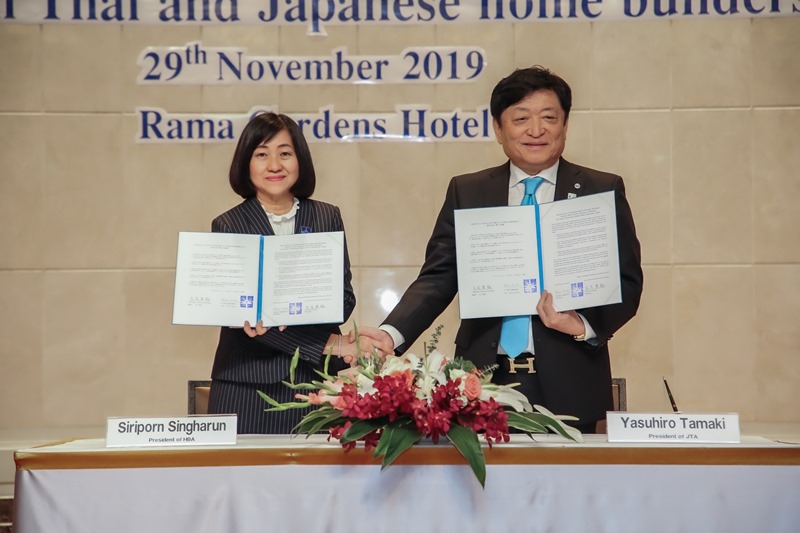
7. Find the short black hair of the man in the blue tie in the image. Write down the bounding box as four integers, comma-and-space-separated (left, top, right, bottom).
489, 65, 572, 122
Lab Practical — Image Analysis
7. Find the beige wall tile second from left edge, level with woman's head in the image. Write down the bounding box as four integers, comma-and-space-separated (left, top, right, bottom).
42, 114, 130, 268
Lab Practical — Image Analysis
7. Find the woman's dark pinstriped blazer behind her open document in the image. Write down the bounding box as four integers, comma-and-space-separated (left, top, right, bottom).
211, 198, 356, 383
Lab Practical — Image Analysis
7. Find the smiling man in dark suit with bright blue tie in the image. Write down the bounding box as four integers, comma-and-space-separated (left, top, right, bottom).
360, 66, 644, 432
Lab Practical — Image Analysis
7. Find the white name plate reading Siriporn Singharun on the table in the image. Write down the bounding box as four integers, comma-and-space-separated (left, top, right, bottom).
106, 415, 236, 448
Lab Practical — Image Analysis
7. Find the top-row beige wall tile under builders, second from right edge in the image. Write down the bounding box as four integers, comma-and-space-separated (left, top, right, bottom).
672, 19, 753, 107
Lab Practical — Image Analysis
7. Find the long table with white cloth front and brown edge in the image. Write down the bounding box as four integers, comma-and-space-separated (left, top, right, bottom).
14, 435, 800, 533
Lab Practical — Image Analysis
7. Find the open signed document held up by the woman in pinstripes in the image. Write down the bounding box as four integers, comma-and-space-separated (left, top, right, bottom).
172, 232, 344, 327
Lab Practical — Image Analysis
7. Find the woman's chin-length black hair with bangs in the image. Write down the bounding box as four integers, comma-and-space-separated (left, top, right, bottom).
229, 112, 317, 198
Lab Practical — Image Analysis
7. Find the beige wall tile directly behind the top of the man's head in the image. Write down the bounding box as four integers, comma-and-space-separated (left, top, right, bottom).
512, 21, 594, 110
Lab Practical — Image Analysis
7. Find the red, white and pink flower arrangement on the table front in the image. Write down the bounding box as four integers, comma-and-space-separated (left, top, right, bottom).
258, 326, 583, 486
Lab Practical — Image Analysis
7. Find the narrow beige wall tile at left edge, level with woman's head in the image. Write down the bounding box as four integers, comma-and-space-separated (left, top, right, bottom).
0, 115, 45, 268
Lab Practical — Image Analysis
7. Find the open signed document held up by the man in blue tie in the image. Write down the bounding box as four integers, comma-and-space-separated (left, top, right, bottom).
455, 191, 622, 319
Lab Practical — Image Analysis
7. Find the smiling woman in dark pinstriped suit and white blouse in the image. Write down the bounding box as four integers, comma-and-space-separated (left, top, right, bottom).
208, 113, 356, 434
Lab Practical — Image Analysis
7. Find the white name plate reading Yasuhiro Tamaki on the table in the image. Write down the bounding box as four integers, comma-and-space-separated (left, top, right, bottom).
606, 411, 741, 443
